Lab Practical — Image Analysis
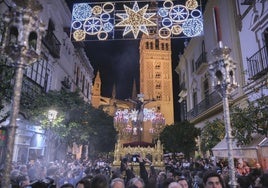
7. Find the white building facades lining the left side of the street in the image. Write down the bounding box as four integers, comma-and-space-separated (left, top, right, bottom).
0, 0, 94, 162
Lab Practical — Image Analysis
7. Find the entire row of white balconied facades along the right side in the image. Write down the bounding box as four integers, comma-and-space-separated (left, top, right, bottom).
176, 0, 268, 168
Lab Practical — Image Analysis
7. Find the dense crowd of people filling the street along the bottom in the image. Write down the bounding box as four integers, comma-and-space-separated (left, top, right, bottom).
1, 155, 268, 188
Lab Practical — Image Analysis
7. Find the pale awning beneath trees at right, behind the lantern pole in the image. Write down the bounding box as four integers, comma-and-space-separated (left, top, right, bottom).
212, 135, 268, 158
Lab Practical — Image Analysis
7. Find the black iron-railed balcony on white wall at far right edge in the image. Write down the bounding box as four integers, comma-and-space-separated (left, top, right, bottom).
247, 46, 268, 80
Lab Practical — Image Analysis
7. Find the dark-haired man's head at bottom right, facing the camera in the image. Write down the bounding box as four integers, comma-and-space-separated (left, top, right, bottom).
203, 171, 225, 188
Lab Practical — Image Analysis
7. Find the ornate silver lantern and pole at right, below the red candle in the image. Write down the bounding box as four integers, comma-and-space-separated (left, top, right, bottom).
209, 45, 237, 187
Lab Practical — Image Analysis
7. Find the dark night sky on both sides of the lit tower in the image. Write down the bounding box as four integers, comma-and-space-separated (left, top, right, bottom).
66, 0, 197, 120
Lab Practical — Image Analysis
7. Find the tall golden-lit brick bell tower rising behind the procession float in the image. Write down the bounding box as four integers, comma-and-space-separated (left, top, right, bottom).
140, 33, 174, 125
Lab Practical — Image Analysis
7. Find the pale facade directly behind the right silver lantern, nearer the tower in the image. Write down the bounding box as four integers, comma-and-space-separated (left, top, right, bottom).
176, 1, 244, 128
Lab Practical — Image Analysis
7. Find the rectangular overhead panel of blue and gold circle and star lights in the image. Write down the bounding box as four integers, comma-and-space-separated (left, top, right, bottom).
70, 0, 203, 41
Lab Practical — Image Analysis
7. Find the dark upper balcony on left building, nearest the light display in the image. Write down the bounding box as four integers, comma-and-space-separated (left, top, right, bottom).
42, 33, 61, 58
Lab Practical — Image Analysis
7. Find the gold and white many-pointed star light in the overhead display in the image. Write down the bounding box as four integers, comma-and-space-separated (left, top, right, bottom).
115, 1, 156, 39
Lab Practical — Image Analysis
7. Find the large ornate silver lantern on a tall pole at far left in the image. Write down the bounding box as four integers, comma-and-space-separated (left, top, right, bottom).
0, 0, 45, 187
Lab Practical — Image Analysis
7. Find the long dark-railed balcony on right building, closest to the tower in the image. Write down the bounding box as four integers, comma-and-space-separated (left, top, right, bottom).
187, 91, 222, 121
